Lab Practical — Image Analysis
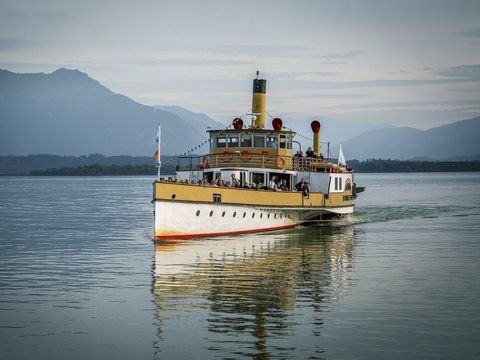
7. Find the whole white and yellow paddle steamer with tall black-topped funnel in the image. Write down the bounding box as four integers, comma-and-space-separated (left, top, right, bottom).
152, 73, 356, 239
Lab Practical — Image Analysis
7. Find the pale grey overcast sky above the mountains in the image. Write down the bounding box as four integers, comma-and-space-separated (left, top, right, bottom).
0, 0, 480, 129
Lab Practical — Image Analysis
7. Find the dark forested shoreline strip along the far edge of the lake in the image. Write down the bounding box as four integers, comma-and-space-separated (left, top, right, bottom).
0, 154, 480, 176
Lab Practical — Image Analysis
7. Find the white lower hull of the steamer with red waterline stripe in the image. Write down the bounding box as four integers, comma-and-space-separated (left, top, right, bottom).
155, 201, 353, 239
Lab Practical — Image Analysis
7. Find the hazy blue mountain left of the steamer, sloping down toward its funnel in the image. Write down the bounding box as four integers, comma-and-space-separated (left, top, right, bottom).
0, 69, 218, 156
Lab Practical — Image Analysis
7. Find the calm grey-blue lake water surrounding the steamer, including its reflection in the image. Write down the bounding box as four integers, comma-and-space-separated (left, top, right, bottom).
0, 173, 480, 359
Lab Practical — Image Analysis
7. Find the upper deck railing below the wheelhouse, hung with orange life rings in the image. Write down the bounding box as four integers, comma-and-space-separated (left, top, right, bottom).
176, 153, 336, 172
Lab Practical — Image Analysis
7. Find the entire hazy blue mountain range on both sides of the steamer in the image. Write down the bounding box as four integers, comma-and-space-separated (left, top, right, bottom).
0, 69, 480, 160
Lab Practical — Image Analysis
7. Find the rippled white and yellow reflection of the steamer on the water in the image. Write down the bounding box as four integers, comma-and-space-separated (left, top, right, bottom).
153, 226, 354, 357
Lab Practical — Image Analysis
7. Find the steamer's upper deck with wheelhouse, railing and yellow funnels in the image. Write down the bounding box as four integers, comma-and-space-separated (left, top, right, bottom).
172, 74, 349, 172
